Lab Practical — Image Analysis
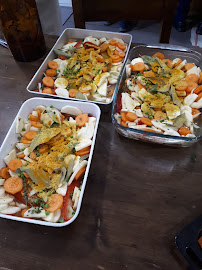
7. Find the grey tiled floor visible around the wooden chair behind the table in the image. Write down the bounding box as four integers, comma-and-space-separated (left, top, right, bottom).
61, 7, 192, 47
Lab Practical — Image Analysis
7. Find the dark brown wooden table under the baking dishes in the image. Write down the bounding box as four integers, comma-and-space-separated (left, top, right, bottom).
0, 37, 202, 270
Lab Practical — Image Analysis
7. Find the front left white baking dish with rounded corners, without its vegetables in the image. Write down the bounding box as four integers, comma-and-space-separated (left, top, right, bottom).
0, 98, 100, 227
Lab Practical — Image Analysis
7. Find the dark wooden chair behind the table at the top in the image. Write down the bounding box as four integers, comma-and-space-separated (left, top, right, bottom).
72, 0, 178, 43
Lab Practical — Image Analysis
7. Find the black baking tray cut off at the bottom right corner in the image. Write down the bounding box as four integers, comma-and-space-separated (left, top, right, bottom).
175, 216, 202, 270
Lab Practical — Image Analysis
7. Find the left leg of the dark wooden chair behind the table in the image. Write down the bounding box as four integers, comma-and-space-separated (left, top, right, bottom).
72, 0, 86, 29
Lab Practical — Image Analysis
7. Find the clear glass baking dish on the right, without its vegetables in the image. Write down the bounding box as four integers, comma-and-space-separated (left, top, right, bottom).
111, 44, 202, 147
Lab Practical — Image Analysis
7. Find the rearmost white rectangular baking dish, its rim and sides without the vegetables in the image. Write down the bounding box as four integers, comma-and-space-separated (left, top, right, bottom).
27, 28, 132, 105
